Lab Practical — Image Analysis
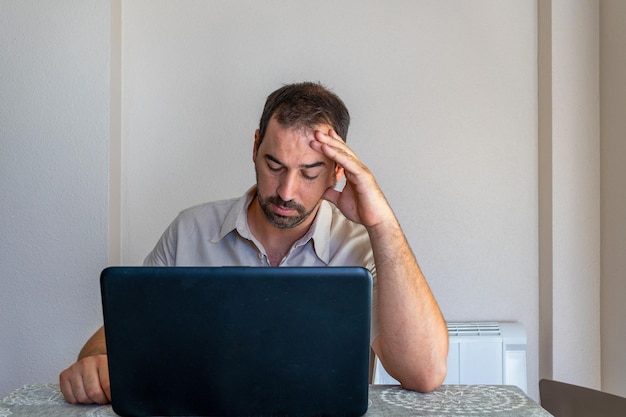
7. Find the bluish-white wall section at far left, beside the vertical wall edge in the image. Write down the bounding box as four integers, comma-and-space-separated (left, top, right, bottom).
0, 0, 109, 397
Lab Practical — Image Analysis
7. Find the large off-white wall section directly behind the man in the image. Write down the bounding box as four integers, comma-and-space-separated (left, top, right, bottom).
121, 0, 538, 396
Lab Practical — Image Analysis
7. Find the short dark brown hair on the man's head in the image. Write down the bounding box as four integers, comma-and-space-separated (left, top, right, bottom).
259, 82, 350, 143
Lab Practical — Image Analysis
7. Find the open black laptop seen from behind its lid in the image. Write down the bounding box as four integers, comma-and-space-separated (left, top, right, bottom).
100, 267, 372, 417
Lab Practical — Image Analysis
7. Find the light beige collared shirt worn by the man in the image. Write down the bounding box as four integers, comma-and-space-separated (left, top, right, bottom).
144, 187, 379, 341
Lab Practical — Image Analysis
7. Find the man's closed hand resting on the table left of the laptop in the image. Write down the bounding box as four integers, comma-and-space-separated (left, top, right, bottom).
59, 355, 111, 404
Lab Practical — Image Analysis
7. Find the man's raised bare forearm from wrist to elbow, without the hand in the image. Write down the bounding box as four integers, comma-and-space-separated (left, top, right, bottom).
368, 217, 448, 391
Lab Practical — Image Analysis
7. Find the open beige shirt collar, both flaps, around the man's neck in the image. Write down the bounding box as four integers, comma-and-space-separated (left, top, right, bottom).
218, 186, 332, 264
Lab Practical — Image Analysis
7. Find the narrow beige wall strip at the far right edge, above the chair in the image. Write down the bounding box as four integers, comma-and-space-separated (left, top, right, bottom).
600, 0, 626, 397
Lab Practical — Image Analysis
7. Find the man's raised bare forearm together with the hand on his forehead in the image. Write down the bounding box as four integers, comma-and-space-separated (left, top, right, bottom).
310, 130, 448, 391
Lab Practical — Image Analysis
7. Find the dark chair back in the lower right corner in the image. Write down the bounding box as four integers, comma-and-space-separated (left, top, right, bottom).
539, 379, 626, 417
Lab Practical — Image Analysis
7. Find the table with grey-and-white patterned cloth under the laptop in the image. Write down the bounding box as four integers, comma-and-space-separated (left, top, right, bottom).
0, 384, 550, 417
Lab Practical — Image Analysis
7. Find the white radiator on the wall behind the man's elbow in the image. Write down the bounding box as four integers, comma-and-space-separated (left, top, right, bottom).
374, 322, 527, 392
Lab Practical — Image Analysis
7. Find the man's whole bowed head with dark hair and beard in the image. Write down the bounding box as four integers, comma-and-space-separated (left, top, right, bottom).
252, 83, 350, 229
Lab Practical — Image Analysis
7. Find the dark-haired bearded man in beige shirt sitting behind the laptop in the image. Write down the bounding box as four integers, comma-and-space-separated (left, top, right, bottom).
60, 83, 448, 403
